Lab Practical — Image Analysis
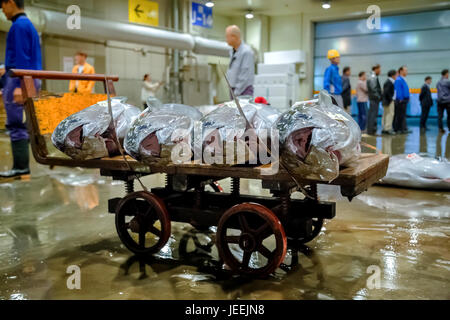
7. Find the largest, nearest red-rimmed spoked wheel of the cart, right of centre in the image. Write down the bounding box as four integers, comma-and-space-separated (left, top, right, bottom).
216, 203, 287, 277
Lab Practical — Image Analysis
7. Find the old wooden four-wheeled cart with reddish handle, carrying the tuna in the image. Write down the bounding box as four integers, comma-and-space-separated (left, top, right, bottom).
11, 70, 389, 276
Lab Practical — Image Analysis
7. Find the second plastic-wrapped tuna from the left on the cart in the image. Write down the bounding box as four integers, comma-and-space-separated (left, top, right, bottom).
124, 102, 202, 164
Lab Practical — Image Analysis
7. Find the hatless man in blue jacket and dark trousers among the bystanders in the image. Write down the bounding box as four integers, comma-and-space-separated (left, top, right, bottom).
394, 66, 411, 134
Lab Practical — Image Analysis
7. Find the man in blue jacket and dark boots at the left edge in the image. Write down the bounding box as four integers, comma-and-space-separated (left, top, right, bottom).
0, 0, 42, 177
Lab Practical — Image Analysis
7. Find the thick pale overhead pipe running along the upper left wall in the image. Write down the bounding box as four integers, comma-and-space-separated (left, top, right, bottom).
39, 10, 230, 57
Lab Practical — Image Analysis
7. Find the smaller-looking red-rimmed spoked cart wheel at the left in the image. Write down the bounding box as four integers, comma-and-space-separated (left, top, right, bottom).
116, 191, 171, 254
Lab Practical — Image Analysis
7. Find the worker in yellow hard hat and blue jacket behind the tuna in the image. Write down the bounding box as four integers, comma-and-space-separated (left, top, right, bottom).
323, 49, 344, 108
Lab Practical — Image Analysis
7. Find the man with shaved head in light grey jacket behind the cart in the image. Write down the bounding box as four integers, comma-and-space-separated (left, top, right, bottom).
225, 25, 255, 97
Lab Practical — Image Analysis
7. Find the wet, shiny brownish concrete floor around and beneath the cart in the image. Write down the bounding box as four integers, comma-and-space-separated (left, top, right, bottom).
0, 119, 450, 299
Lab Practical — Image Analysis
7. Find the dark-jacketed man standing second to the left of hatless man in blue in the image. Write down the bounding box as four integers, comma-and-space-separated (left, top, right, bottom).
367, 64, 382, 135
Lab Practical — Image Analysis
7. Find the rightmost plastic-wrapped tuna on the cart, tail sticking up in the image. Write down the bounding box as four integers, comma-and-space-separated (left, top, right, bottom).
275, 91, 361, 181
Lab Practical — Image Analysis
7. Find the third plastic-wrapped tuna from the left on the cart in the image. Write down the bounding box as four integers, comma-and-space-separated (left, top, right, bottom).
196, 100, 280, 165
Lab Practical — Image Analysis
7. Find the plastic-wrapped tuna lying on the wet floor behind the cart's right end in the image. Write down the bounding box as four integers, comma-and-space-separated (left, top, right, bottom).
382, 153, 450, 190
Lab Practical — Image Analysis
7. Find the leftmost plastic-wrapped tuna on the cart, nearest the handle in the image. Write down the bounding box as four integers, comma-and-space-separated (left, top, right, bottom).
52, 97, 140, 160
